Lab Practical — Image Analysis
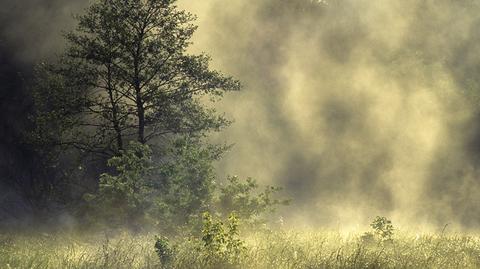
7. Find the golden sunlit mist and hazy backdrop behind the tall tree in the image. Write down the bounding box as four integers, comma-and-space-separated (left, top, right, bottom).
0, 0, 480, 229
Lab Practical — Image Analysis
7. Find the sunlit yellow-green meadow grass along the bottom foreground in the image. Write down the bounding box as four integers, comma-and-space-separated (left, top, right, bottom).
0, 228, 480, 269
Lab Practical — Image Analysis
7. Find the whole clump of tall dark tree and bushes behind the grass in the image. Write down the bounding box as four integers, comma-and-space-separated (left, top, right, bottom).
1, 0, 285, 231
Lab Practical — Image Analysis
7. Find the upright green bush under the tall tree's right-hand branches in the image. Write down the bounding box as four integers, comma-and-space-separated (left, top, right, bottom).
150, 136, 224, 234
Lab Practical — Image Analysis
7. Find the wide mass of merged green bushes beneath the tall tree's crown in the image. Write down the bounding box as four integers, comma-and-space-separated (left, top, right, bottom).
84, 137, 222, 230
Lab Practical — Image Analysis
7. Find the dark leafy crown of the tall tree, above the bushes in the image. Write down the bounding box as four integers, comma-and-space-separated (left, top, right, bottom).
33, 0, 240, 155
